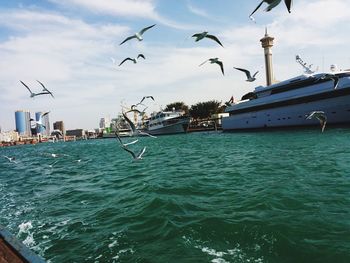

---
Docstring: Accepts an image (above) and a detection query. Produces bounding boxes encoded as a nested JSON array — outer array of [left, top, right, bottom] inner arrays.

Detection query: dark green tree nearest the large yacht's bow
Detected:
[[189, 100, 223, 119]]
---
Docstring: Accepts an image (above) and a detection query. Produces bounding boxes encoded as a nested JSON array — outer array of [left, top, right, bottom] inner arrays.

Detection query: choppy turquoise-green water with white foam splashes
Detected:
[[0, 129, 350, 263]]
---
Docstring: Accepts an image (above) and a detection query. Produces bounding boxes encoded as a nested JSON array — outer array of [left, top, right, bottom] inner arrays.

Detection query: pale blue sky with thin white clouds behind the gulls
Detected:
[[0, 0, 350, 131]]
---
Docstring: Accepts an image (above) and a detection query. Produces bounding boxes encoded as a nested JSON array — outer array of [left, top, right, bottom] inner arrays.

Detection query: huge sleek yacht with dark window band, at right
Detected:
[[222, 70, 350, 131]]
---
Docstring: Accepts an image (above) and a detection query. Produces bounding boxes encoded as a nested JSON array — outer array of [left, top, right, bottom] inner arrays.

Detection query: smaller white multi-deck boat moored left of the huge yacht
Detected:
[[143, 110, 190, 135]]
